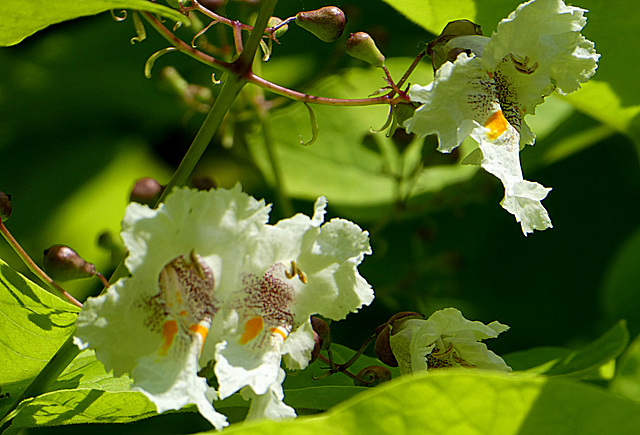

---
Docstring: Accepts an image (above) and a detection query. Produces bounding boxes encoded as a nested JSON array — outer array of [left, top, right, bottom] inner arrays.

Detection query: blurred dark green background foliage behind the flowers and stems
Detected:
[[0, 0, 640, 431]]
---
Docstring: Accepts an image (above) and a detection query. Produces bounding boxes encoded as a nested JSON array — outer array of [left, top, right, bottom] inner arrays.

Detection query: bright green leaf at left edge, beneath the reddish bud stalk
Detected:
[[0, 260, 79, 416]]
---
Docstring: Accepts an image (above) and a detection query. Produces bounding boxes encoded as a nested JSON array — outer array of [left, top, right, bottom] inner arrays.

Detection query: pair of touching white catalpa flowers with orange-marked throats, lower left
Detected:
[[76, 186, 373, 429]]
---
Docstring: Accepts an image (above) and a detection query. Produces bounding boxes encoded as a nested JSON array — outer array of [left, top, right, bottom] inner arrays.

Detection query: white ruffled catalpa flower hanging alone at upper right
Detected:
[[404, 0, 600, 236]]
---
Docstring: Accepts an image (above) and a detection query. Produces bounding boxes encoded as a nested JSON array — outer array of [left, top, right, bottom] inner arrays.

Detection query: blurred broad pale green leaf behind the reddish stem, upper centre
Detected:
[[248, 59, 476, 207]]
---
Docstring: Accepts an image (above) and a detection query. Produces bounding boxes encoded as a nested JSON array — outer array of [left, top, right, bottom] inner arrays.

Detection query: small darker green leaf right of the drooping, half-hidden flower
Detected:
[[504, 320, 629, 376]]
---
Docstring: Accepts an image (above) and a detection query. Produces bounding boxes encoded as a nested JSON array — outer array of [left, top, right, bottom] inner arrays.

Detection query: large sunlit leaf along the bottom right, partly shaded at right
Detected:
[[198, 369, 640, 435]]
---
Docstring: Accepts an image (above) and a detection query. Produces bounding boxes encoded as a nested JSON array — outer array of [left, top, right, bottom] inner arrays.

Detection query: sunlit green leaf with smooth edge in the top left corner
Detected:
[[0, 0, 190, 46]]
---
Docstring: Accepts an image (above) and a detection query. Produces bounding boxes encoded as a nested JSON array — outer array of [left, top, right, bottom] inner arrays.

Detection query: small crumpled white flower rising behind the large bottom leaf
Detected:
[[389, 308, 511, 374]]
